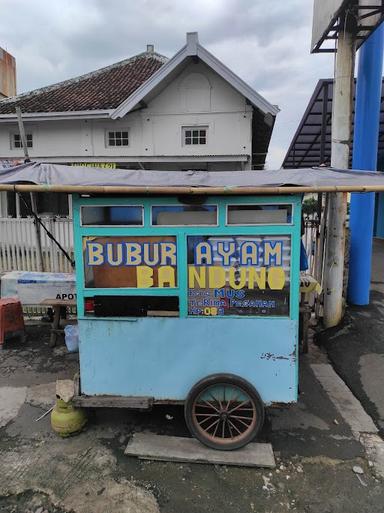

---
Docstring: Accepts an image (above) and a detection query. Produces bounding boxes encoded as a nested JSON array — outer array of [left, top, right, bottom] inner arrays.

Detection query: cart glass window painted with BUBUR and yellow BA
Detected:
[[83, 235, 177, 289]]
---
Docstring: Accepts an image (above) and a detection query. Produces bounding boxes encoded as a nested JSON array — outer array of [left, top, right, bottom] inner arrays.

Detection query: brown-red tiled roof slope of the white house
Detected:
[[0, 52, 167, 114]]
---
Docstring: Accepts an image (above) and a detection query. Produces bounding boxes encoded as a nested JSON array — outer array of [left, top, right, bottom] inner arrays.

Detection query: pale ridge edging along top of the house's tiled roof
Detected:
[[0, 51, 169, 105]]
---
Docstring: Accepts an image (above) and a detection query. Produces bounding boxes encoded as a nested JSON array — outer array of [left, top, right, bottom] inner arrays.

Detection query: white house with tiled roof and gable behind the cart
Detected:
[[0, 32, 279, 215]]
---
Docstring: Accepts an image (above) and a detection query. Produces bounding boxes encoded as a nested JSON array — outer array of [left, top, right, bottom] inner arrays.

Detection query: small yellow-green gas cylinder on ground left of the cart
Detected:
[[51, 399, 87, 437]]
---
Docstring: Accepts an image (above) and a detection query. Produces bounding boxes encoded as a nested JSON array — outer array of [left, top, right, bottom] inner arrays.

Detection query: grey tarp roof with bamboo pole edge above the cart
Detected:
[[0, 162, 384, 195]]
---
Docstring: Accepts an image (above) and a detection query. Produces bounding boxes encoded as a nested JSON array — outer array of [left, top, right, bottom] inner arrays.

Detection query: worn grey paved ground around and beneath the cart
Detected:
[[0, 320, 384, 513]]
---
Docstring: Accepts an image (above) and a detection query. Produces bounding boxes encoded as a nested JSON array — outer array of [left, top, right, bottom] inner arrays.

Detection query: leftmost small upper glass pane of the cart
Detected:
[[81, 205, 144, 226]]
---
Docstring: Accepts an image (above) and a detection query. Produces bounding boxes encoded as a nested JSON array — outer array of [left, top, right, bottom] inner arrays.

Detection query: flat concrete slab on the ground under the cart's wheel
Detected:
[[125, 433, 276, 468]]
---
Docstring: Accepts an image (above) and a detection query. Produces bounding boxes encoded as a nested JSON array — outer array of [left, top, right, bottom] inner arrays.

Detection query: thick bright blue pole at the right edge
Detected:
[[348, 25, 384, 305]]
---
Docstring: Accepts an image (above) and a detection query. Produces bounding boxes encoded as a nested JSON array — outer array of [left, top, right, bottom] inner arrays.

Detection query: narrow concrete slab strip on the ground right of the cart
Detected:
[[311, 363, 378, 436]]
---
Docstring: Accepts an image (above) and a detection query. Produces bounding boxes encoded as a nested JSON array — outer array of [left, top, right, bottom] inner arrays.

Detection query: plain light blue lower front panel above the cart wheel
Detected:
[[80, 319, 297, 404]]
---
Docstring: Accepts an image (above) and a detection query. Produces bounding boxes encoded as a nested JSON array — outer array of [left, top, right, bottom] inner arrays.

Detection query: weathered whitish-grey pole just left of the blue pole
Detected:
[[324, 24, 355, 328]]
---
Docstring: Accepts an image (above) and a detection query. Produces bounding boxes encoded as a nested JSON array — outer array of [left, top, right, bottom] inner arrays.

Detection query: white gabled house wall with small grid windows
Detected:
[[0, 62, 252, 169]]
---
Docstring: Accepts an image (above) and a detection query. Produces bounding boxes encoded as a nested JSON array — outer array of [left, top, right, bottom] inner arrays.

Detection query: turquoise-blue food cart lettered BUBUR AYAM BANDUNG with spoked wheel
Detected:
[[73, 194, 301, 449]]
